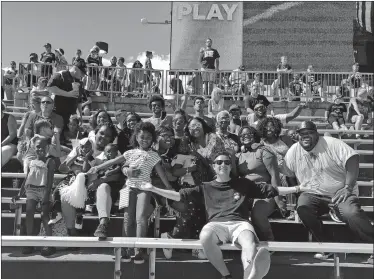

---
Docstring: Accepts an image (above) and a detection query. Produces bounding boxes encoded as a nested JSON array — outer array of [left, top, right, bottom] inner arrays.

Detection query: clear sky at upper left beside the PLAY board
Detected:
[[1, 2, 171, 68]]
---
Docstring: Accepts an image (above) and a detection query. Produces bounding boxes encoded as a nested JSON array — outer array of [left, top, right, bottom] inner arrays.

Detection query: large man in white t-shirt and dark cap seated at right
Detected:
[[281, 121, 374, 259]]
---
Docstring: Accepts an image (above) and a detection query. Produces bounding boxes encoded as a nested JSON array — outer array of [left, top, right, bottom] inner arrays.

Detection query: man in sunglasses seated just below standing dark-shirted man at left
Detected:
[[25, 97, 64, 142]]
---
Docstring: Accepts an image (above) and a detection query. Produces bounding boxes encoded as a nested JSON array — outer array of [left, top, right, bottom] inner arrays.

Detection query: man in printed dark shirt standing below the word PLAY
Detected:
[[199, 38, 220, 95]]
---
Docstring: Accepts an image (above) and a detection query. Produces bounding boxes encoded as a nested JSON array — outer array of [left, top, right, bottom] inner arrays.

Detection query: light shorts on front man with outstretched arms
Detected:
[[201, 221, 259, 245]]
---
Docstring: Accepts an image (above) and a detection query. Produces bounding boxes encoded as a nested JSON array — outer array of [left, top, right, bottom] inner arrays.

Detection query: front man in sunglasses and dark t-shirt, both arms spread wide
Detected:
[[140, 152, 307, 279]]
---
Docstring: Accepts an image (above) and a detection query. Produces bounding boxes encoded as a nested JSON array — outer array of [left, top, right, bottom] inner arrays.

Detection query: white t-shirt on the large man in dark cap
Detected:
[[283, 137, 358, 198]]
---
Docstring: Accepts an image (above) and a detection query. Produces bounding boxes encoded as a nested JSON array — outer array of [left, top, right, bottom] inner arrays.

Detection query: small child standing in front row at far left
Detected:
[[14, 134, 56, 256]]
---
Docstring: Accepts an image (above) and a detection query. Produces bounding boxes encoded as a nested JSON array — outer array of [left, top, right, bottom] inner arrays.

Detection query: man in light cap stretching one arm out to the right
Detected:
[[247, 103, 306, 128]]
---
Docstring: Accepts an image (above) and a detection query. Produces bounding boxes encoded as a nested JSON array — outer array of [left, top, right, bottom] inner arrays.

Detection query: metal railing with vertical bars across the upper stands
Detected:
[[13, 63, 374, 101]]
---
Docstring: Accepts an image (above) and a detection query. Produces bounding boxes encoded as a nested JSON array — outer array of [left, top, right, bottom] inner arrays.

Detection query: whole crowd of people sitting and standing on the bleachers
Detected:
[[1, 39, 373, 279]]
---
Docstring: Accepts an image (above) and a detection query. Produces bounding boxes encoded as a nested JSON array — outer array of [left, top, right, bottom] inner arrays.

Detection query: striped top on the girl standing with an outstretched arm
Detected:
[[123, 148, 161, 188]]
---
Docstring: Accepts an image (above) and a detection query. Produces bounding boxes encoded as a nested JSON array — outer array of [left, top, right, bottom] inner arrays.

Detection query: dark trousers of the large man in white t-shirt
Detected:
[[297, 192, 374, 243]]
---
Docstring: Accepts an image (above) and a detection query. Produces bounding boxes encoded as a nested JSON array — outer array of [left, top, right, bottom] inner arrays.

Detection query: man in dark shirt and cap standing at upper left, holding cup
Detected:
[[47, 61, 86, 127]]
